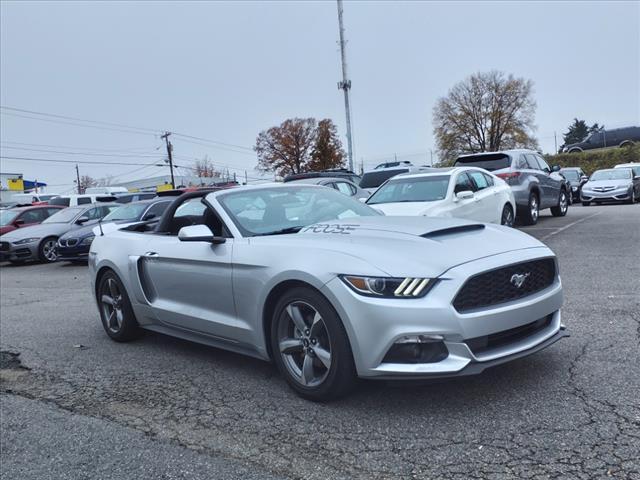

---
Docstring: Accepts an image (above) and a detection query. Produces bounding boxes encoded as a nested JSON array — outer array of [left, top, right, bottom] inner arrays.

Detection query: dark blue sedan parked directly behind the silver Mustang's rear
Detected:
[[56, 197, 173, 262]]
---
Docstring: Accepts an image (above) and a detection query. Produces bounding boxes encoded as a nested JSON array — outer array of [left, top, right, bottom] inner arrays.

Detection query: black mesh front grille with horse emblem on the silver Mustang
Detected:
[[453, 258, 556, 312]]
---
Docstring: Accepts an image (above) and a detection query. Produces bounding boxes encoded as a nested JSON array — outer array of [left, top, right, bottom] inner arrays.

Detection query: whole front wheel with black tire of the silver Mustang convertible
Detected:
[[271, 287, 356, 402]]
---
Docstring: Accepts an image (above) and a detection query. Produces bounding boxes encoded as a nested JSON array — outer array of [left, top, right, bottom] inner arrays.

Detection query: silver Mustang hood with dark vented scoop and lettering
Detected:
[[251, 216, 549, 277]]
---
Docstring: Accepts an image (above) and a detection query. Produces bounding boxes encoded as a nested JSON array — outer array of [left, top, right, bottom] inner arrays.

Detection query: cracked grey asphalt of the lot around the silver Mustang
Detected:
[[0, 204, 640, 480]]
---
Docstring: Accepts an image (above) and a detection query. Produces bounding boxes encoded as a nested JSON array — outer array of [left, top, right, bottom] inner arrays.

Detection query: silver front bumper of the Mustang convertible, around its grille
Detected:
[[324, 248, 567, 379]]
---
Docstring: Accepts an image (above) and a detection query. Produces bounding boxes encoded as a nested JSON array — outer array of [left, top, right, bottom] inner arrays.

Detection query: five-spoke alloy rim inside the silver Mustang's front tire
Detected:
[[278, 301, 331, 387]]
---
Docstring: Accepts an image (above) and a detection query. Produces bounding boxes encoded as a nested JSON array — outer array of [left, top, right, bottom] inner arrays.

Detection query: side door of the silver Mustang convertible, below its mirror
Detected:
[[140, 197, 239, 341]]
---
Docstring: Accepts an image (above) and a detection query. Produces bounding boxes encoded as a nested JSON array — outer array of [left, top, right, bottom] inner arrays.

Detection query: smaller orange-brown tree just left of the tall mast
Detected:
[[253, 118, 316, 176]]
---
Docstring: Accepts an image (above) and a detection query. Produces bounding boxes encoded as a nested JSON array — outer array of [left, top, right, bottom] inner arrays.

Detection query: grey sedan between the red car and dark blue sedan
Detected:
[[0, 203, 119, 263]]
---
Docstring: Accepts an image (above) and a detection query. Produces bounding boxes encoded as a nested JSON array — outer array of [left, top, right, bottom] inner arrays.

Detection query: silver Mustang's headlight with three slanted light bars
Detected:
[[340, 275, 434, 298]]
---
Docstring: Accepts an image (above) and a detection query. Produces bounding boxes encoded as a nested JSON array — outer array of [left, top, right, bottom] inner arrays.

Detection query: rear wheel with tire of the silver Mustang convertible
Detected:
[[96, 271, 141, 342]]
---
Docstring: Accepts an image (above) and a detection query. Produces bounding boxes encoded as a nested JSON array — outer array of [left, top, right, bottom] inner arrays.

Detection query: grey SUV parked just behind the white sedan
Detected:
[[455, 150, 571, 225]]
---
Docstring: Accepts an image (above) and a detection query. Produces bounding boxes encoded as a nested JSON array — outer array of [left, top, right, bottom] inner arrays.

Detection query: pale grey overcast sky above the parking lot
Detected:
[[0, 0, 640, 192]]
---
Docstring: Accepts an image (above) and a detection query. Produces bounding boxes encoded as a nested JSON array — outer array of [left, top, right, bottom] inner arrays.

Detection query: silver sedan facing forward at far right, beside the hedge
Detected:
[[580, 168, 640, 206]]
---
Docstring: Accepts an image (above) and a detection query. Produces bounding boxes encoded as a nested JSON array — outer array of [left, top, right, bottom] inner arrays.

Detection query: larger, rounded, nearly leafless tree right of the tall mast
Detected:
[[433, 71, 537, 160]]
